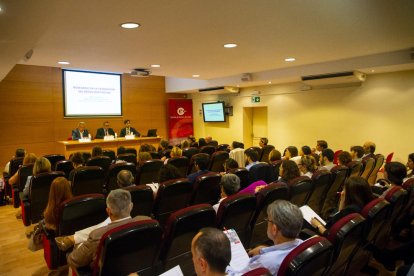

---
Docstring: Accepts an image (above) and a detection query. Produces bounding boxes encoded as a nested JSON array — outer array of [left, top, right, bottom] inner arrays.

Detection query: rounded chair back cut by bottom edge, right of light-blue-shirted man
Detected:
[[277, 236, 333, 276]]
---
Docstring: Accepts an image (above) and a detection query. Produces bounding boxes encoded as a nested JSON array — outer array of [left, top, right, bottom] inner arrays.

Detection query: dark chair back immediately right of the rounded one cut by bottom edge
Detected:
[[326, 213, 365, 275]]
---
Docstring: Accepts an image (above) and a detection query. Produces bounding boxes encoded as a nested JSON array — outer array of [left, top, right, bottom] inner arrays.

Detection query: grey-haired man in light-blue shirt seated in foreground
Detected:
[[228, 200, 303, 275]]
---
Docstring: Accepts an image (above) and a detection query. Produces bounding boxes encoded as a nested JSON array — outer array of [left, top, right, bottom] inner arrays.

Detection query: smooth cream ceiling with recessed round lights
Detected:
[[0, 0, 414, 90]]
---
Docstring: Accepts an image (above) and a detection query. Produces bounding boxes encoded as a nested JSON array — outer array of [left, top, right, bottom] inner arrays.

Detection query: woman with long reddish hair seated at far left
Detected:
[[43, 177, 73, 231]]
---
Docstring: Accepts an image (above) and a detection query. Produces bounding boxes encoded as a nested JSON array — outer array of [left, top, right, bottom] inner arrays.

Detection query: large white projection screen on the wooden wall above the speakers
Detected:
[[62, 69, 122, 117]]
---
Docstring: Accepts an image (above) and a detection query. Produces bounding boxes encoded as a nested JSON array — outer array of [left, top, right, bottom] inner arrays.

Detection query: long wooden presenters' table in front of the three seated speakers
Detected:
[[57, 137, 161, 159]]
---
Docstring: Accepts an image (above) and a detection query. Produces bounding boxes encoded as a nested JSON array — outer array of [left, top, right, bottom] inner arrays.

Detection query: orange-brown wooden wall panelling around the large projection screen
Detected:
[[0, 65, 183, 169]]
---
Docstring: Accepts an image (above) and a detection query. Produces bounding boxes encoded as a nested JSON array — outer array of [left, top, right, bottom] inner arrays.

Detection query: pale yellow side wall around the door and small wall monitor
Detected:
[[191, 71, 414, 164]]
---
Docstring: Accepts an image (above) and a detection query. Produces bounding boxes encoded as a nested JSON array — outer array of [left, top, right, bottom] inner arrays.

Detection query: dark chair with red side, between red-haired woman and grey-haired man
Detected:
[[43, 194, 108, 269]]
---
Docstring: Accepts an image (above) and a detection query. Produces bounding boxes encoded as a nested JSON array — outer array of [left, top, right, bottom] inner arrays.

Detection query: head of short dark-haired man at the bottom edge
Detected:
[[191, 227, 231, 276]]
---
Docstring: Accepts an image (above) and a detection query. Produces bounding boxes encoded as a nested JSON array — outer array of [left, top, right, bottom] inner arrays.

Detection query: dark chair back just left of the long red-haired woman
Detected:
[[29, 172, 65, 223]]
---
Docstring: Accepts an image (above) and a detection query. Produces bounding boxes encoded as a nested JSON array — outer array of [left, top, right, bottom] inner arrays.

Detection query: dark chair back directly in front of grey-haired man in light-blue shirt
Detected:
[[249, 182, 289, 248]]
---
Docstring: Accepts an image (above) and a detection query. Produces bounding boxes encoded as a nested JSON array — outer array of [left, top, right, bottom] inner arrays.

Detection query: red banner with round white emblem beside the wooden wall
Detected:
[[168, 99, 194, 141]]
